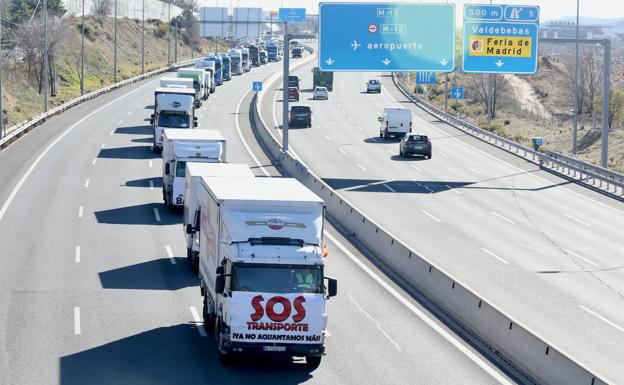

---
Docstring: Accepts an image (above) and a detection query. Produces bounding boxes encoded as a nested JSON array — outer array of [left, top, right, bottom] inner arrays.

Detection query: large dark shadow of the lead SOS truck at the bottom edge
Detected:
[[59, 324, 322, 385]]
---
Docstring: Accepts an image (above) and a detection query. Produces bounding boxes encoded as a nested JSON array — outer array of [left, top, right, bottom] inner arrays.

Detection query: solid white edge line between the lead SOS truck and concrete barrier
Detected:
[[323, 231, 511, 385]]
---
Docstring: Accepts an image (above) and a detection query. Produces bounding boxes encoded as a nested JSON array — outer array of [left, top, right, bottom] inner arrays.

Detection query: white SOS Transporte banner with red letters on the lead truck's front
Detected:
[[230, 291, 325, 344]]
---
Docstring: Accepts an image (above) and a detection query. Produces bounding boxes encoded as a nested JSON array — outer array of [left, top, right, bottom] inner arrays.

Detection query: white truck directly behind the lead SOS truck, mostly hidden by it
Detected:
[[182, 162, 254, 274]]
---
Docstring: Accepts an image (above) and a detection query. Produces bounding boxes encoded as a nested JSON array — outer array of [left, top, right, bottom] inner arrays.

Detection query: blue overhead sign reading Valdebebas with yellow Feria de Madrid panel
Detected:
[[462, 4, 540, 74]]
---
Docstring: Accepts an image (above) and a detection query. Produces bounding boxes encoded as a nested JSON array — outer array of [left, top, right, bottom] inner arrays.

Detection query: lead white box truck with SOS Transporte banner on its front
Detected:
[[198, 177, 337, 368]]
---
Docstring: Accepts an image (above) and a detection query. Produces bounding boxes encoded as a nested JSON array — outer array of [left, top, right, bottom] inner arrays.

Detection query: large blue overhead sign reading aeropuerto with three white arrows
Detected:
[[319, 3, 455, 72]]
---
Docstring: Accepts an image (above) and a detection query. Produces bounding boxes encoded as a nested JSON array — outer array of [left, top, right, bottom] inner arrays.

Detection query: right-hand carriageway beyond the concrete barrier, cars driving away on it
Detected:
[[261, 48, 624, 382]]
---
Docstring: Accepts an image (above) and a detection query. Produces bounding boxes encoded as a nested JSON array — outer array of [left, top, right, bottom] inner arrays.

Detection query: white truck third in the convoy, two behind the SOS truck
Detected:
[[162, 129, 225, 209]]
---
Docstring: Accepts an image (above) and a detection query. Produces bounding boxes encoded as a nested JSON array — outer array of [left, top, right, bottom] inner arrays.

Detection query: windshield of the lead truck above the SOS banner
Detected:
[[230, 264, 323, 294]]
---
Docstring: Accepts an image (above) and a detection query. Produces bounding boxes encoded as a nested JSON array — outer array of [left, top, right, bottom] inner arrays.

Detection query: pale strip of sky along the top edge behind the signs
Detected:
[[205, 0, 624, 20]]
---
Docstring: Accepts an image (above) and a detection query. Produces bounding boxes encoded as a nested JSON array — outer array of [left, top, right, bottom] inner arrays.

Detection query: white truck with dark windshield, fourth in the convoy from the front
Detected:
[[150, 87, 197, 154]]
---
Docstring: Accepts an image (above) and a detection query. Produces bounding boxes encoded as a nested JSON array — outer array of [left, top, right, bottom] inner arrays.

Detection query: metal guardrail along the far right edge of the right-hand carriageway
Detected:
[[392, 73, 624, 200]]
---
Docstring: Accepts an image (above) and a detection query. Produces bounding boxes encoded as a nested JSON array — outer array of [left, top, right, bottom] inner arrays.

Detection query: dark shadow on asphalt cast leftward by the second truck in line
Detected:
[[98, 256, 199, 290]]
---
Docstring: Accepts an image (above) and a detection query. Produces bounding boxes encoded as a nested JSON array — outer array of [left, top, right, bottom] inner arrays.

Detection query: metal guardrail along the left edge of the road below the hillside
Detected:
[[0, 59, 194, 150]]
